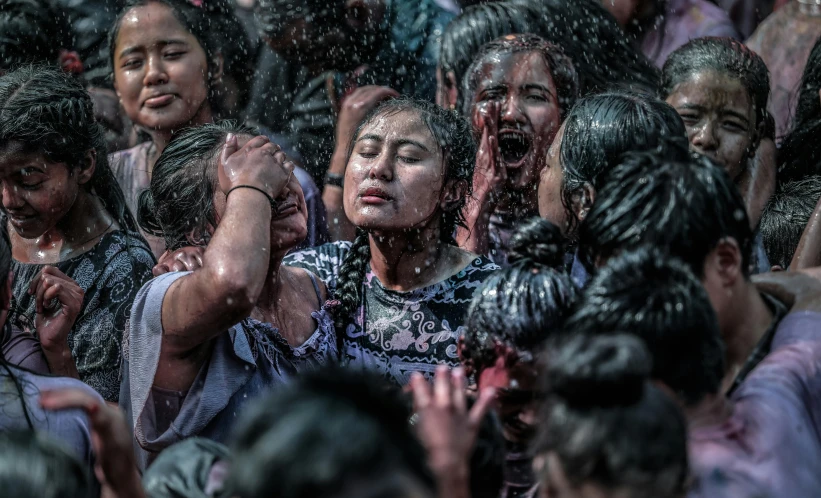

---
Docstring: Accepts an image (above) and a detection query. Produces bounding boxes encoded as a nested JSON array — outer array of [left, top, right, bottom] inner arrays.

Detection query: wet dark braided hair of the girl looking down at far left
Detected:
[[0, 66, 138, 232]]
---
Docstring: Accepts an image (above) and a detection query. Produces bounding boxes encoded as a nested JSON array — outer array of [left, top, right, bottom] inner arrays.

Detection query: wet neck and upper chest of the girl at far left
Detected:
[[10, 190, 114, 263]]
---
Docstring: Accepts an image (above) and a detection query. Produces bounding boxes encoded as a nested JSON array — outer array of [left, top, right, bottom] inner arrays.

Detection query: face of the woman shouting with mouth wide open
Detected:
[[473, 52, 561, 191]]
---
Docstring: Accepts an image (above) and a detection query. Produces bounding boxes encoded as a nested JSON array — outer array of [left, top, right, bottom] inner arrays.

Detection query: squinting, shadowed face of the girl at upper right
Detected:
[[667, 71, 757, 180]]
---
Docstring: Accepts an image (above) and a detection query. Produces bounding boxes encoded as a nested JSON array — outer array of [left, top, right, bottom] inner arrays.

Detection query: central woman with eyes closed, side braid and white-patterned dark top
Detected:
[[286, 99, 498, 385]]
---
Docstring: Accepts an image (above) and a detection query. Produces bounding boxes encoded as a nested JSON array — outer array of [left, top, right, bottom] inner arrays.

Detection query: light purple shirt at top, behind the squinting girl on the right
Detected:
[[641, 0, 739, 67]]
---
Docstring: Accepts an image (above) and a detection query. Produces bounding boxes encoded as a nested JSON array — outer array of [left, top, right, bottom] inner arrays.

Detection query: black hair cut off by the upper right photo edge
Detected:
[[777, 38, 821, 183]]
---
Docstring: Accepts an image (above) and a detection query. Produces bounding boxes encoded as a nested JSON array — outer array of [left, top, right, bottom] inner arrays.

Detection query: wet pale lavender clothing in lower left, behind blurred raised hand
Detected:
[[0, 367, 102, 482]]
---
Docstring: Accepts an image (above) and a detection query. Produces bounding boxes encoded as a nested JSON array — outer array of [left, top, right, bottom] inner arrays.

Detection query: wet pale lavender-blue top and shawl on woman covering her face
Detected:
[[120, 272, 339, 469]]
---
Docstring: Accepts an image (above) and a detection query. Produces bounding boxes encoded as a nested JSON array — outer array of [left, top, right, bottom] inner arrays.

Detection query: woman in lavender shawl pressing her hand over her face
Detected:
[[121, 122, 338, 468]]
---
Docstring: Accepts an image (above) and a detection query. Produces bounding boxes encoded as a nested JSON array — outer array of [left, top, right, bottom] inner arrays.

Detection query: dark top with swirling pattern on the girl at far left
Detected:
[[9, 230, 154, 402]]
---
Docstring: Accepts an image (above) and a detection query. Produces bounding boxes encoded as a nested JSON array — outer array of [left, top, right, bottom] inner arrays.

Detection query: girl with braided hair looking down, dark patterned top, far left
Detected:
[[0, 68, 154, 401]]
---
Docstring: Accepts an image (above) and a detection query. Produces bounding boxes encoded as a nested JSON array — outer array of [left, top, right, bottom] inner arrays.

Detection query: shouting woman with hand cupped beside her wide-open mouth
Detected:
[[457, 35, 579, 264]]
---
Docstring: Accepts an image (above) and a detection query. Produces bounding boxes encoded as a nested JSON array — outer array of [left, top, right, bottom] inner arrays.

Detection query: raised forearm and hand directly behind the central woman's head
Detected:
[[322, 86, 399, 241]]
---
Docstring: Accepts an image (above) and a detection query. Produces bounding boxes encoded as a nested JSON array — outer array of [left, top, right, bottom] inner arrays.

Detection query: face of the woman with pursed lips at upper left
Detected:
[[113, 2, 211, 132]]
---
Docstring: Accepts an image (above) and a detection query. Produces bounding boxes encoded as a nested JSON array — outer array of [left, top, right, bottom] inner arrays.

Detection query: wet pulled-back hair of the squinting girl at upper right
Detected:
[[661, 36, 772, 139]]
